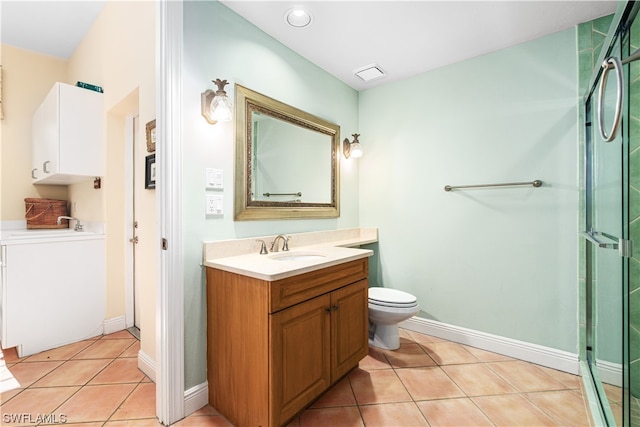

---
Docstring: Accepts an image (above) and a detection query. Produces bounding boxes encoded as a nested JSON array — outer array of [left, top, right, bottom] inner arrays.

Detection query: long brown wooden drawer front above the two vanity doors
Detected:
[[270, 258, 369, 313]]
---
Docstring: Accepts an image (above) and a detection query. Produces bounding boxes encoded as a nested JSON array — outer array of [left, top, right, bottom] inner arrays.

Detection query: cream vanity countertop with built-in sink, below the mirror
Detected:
[[204, 246, 373, 281]]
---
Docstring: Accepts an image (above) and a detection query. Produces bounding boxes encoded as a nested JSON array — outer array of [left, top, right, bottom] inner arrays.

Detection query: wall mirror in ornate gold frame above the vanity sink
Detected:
[[234, 84, 340, 221]]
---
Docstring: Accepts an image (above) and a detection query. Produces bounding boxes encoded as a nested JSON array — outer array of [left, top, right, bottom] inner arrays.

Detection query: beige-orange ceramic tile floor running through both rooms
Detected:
[[0, 330, 589, 427]]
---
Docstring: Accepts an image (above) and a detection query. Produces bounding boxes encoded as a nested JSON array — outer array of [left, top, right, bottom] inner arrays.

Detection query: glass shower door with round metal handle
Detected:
[[583, 30, 629, 426]]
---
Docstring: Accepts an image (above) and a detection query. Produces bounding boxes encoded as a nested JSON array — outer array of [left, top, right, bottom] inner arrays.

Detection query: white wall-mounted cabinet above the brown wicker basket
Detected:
[[31, 83, 105, 185]]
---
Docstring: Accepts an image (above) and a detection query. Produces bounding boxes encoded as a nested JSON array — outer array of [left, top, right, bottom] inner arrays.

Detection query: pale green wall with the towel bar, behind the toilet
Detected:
[[359, 29, 579, 354]]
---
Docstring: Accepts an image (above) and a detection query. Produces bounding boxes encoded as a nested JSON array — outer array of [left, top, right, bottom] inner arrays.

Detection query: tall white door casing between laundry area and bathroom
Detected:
[[156, 0, 185, 425]]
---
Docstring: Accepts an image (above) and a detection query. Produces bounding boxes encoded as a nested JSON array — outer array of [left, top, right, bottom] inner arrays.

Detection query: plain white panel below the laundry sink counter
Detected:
[[2, 238, 106, 357]]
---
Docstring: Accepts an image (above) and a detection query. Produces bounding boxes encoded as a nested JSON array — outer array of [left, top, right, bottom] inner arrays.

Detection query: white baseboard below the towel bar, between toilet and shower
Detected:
[[399, 317, 580, 375]]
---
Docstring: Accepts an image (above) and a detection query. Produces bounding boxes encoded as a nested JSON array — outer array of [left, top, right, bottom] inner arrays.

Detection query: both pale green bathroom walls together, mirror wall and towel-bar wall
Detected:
[[183, 1, 616, 394]]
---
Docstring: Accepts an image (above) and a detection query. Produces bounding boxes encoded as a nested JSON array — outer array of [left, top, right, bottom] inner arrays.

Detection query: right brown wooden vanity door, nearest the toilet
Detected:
[[331, 279, 369, 382]]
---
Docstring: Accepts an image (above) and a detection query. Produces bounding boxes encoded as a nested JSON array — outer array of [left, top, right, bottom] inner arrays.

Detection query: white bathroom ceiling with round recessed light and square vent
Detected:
[[222, 0, 617, 90]]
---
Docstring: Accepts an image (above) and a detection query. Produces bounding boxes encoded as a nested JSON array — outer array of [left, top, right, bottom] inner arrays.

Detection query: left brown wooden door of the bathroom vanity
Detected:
[[270, 294, 331, 425]]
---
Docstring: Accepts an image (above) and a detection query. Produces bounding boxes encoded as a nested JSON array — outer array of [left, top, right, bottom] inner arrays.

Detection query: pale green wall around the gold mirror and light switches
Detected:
[[183, 1, 359, 389]]
